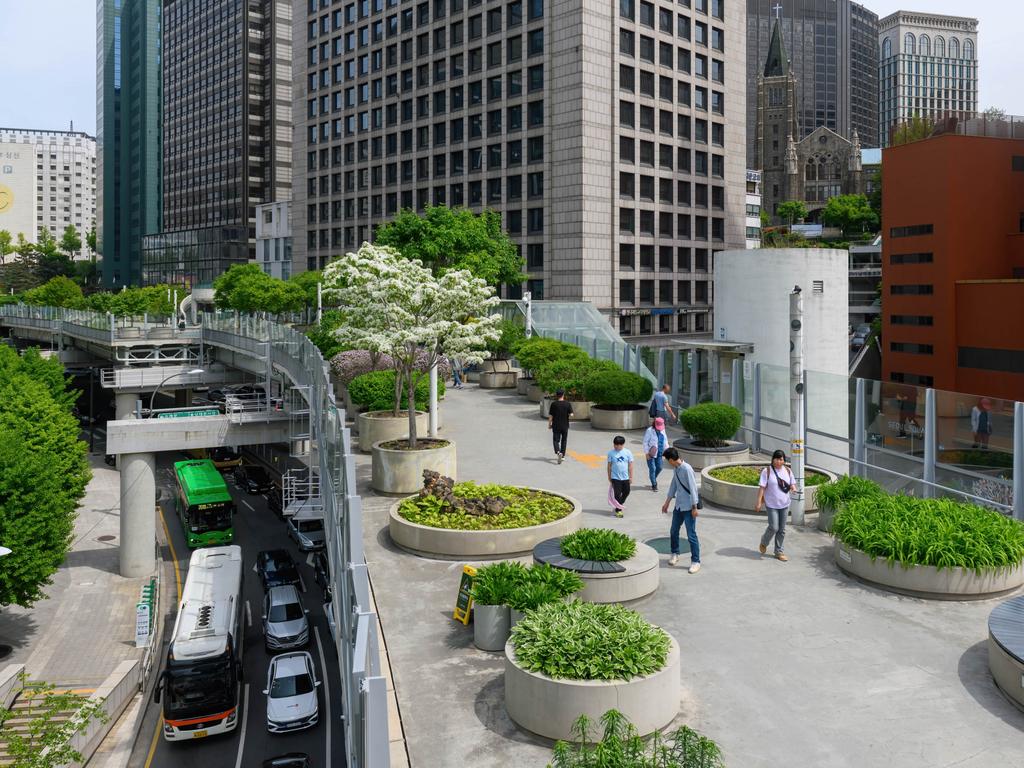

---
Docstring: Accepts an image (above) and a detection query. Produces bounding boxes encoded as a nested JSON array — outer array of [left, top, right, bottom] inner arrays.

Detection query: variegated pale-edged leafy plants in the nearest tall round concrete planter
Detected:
[[512, 600, 671, 680]]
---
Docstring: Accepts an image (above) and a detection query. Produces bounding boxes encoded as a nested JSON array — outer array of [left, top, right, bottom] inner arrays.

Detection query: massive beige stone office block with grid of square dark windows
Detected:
[[293, 0, 745, 336]]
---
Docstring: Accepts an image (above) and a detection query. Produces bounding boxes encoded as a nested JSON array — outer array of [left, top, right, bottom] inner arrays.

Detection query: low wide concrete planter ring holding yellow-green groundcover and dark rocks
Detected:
[[388, 493, 583, 559]]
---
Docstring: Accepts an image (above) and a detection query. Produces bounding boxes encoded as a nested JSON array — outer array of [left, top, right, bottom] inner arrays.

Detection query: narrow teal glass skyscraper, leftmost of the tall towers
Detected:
[[96, 0, 162, 288]]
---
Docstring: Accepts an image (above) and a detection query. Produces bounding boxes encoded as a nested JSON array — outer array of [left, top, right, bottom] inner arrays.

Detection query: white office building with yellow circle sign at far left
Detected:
[[0, 128, 96, 259]]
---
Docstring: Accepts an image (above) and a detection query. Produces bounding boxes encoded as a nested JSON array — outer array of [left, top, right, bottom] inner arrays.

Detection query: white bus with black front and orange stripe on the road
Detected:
[[154, 546, 245, 741]]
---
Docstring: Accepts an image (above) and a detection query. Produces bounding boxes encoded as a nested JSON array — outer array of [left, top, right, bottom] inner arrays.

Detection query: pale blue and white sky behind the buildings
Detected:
[[0, 0, 1024, 134]]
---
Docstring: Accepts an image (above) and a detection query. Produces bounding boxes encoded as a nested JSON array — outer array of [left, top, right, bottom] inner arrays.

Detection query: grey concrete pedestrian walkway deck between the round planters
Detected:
[[356, 385, 1024, 768]]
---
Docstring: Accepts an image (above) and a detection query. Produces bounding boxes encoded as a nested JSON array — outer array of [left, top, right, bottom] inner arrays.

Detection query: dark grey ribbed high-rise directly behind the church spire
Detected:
[[746, 0, 879, 168]]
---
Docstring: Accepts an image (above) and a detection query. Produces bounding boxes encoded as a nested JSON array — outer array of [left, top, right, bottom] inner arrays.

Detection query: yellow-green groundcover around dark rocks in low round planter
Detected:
[[398, 482, 572, 530]]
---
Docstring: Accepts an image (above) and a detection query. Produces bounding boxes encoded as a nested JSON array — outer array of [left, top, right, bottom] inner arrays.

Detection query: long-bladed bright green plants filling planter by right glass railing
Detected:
[[833, 496, 1024, 573]]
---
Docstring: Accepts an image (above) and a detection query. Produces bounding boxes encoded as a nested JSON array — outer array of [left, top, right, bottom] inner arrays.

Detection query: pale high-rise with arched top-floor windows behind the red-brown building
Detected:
[[879, 10, 978, 146]]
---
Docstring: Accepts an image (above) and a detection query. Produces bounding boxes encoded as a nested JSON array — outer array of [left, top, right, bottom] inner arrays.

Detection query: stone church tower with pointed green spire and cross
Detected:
[[757, 17, 800, 218]]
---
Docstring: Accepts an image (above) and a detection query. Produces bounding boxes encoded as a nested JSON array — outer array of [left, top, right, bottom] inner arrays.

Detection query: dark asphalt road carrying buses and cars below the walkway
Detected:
[[129, 454, 345, 768]]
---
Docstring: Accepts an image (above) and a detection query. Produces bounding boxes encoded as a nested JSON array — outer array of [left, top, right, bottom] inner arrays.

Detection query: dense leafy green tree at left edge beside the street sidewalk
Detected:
[[0, 347, 91, 607]]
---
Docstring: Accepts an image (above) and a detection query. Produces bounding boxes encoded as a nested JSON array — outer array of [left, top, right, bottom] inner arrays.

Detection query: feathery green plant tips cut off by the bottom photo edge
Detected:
[[548, 710, 725, 768]]
